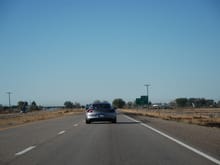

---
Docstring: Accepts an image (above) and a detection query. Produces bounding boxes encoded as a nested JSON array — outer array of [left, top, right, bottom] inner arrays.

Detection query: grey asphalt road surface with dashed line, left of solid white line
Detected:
[[0, 114, 216, 165]]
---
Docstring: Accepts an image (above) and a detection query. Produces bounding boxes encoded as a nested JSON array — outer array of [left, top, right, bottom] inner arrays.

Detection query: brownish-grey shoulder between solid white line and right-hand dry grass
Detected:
[[127, 114, 220, 160]]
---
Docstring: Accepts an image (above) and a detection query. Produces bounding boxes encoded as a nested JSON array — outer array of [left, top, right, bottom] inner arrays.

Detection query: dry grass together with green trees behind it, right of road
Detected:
[[113, 98, 220, 128]]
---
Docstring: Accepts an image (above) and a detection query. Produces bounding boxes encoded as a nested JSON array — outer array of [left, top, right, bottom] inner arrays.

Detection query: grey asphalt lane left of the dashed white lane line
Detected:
[[0, 115, 83, 164]]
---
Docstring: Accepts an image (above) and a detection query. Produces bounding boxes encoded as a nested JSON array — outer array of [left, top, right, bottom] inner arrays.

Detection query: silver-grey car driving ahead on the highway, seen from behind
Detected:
[[86, 102, 117, 124]]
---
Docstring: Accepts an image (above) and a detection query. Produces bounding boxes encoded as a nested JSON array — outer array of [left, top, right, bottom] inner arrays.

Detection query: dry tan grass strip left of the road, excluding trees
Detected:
[[0, 109, 83, 129]]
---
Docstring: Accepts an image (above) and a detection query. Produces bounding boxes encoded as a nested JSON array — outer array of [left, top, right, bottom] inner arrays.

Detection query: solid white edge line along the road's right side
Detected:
[[124, 115, 220, 165]]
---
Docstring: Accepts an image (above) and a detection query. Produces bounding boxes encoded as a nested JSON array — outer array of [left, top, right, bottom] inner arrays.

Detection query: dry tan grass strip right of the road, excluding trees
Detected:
[[122, 108, 220, 127]]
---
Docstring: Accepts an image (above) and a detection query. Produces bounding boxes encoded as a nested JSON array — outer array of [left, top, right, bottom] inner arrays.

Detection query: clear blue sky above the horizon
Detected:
[[0, 0, 220, 105]]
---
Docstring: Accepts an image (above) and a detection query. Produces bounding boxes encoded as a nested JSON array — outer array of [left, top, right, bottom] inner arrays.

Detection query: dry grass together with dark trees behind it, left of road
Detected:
[[0, 101, 84, 130]]
